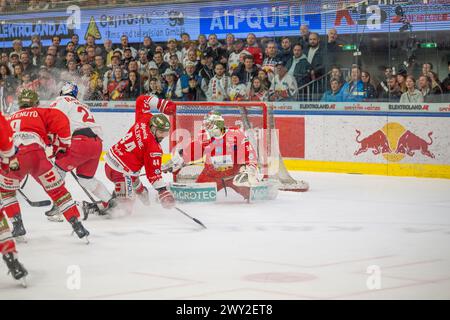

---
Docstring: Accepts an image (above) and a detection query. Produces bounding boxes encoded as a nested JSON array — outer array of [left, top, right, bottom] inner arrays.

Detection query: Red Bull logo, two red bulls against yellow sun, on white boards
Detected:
[[354, 122, 434, 162]]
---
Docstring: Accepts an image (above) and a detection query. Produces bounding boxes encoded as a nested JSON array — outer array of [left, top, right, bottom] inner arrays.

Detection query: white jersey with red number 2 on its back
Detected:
[[50, 96, 103, 139]]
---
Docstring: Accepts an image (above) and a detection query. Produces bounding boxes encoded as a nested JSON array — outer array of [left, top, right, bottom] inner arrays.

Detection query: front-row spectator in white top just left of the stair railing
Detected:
[[269, 61, 298, 101]]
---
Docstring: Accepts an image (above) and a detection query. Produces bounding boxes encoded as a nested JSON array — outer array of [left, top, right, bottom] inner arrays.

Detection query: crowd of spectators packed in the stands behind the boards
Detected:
[[0, 26, 450, 102]]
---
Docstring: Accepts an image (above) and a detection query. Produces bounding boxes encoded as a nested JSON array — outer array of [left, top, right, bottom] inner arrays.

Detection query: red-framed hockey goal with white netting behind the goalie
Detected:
[[170, 101, 309, 191]]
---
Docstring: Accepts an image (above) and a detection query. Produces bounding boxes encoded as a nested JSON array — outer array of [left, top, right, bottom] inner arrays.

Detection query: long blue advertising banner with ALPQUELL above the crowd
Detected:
[[0, 0, 450, 48]]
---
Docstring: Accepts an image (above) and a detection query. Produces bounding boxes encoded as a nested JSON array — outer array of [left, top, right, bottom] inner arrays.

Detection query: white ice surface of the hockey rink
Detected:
[[0, 170, 450, 300]]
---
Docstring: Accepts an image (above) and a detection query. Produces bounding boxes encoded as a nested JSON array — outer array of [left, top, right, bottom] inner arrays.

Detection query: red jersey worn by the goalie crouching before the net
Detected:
[[183, 127, 257, 177]]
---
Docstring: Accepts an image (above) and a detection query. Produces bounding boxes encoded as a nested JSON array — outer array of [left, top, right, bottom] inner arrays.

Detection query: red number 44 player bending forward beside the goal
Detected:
[[105, 114, 175, 209]]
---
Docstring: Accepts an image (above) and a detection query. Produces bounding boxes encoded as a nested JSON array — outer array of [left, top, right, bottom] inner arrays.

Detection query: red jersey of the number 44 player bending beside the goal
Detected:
[[105, 121, 166, 189]]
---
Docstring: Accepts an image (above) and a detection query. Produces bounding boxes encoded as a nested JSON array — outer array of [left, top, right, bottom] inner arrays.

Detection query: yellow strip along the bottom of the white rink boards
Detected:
[[100, 152, 450, 179]]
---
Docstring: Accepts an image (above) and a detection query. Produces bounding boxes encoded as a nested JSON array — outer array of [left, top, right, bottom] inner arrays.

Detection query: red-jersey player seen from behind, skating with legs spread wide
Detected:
[[0, 89, 89, 238]]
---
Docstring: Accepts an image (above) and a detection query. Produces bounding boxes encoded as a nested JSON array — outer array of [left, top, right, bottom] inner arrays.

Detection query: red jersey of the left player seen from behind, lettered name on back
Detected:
[[6, 107, 71, 148]]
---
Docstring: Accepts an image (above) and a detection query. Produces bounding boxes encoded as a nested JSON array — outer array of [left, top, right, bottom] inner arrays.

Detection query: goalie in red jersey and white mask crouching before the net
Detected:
[[162, 111, 260, 199]]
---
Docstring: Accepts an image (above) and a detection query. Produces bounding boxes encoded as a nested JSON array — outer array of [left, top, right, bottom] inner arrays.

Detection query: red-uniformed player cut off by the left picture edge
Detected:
[[0, 113, 28, 281]]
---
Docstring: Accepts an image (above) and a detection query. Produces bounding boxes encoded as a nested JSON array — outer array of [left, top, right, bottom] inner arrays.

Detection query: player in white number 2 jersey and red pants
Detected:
[[46, 82, 113, 221]]
